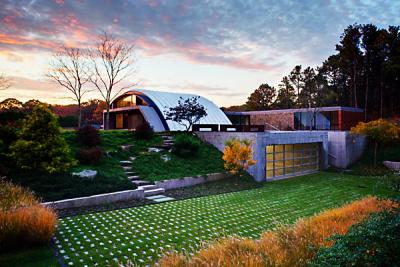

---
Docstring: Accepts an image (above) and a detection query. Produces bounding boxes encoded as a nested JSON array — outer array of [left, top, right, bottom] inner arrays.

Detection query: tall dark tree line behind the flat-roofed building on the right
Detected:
[[227, 24, 400, 121]]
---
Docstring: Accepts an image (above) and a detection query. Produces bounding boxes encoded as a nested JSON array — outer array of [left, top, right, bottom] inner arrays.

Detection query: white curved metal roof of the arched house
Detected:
[[130, 89, 232, 131]]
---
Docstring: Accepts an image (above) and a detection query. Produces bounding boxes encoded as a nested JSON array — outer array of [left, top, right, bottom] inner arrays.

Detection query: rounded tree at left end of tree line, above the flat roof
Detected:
[[246, 83, 276, 110]]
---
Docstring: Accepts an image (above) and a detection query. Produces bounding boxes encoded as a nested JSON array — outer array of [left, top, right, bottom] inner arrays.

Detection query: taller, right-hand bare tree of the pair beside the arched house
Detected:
[[90, 33, 134, 129]]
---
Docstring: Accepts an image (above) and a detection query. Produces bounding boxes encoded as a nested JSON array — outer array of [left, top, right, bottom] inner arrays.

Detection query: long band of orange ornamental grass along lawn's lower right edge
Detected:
[[158, 197, 398, 267]]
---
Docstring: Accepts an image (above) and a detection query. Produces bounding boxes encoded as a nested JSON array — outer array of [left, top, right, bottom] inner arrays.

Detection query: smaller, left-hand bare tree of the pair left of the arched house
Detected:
[[47, 47, 91, 128]]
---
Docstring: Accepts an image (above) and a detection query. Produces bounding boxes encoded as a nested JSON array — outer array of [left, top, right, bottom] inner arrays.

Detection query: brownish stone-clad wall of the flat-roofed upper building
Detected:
[[250, 112, 294, 131]]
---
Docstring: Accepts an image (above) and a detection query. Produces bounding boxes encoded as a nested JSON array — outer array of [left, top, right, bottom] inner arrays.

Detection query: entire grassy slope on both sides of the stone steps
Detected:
[[11, 131, 224, 201]]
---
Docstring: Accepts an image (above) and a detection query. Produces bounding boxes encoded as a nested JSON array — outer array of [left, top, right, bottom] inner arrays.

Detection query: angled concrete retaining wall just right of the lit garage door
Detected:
[[328, 131, 367, 169]]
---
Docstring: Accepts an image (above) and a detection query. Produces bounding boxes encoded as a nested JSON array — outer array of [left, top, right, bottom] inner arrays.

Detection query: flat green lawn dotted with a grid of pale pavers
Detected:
[[55, 172, 394, 266]]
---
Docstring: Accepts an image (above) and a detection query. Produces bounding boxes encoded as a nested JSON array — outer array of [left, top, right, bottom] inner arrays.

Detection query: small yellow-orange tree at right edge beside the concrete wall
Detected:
[[351, 119, 400, 166]]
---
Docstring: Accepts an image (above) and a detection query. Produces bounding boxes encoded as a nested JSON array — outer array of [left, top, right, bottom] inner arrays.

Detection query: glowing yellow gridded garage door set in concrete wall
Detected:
[[266, 143, 319, 179]]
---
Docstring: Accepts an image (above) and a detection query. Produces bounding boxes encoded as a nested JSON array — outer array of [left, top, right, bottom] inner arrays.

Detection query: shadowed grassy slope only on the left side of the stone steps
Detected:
[[11, 131, 139, 201]]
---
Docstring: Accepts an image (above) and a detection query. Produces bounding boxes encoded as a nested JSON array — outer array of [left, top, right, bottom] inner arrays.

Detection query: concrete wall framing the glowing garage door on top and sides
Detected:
[[196, 131, 328, 182]]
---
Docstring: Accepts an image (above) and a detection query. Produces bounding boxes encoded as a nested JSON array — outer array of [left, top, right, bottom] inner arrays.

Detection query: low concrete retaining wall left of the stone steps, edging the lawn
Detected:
[[42, 189, 144, 209]]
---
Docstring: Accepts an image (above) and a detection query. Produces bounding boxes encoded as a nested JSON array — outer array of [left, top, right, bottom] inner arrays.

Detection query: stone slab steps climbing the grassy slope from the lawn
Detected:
[[119, 146, 174, 202]]
